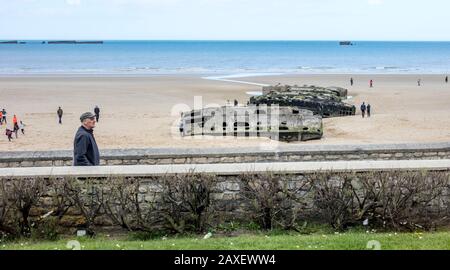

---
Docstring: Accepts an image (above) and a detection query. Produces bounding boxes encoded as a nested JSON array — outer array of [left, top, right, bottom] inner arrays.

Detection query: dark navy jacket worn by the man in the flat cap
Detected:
[[73, 126, 100, 166]]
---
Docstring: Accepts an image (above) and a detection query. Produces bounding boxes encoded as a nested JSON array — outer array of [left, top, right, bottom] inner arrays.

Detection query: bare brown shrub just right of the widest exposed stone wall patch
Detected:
[[240, 172, 308, 230]]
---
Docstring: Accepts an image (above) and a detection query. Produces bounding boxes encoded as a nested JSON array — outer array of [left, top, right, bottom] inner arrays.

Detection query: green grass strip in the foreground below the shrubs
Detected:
[[0, 232, 450, 250]]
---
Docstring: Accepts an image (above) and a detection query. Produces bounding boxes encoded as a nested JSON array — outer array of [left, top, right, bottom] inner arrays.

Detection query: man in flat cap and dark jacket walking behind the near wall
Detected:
[[73, 112, 100, 166]]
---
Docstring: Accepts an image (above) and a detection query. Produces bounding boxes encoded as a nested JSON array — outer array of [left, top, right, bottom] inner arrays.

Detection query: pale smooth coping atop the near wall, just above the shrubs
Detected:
[[0, 159, 450, 178]]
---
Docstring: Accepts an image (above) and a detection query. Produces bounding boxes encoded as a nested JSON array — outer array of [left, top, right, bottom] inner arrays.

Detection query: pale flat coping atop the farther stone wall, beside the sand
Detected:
[[0, 142, 450, 162]]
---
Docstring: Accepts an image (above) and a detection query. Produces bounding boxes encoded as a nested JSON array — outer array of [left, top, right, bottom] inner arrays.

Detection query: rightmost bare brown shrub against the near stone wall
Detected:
[[365, 172, 449, 231]]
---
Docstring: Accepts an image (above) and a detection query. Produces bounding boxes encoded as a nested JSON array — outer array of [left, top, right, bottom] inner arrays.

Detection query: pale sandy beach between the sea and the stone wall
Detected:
[[0, 75, 450, 151]]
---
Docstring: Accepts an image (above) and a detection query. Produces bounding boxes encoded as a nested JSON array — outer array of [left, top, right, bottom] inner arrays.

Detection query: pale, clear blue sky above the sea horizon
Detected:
[[0, 0, 450, 41]]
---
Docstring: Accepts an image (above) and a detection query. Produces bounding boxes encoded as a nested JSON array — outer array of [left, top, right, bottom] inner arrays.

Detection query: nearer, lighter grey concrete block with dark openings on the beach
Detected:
[[180, 106, 323, 142]]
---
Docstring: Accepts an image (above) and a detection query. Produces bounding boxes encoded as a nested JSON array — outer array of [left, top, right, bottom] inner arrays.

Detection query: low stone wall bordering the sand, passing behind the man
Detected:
[[0, 143, 450, 168]]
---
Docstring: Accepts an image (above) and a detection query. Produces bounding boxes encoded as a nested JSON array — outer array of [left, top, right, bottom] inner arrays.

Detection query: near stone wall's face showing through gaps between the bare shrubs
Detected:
[[0, 165, 450, 230]]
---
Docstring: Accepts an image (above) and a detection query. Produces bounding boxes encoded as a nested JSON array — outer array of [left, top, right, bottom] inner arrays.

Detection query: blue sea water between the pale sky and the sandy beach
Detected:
[[0, 41, 450, 75]]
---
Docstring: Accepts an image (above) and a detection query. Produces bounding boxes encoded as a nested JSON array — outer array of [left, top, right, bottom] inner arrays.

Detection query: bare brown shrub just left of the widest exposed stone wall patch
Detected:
[[159, 172, 214, 233]]
